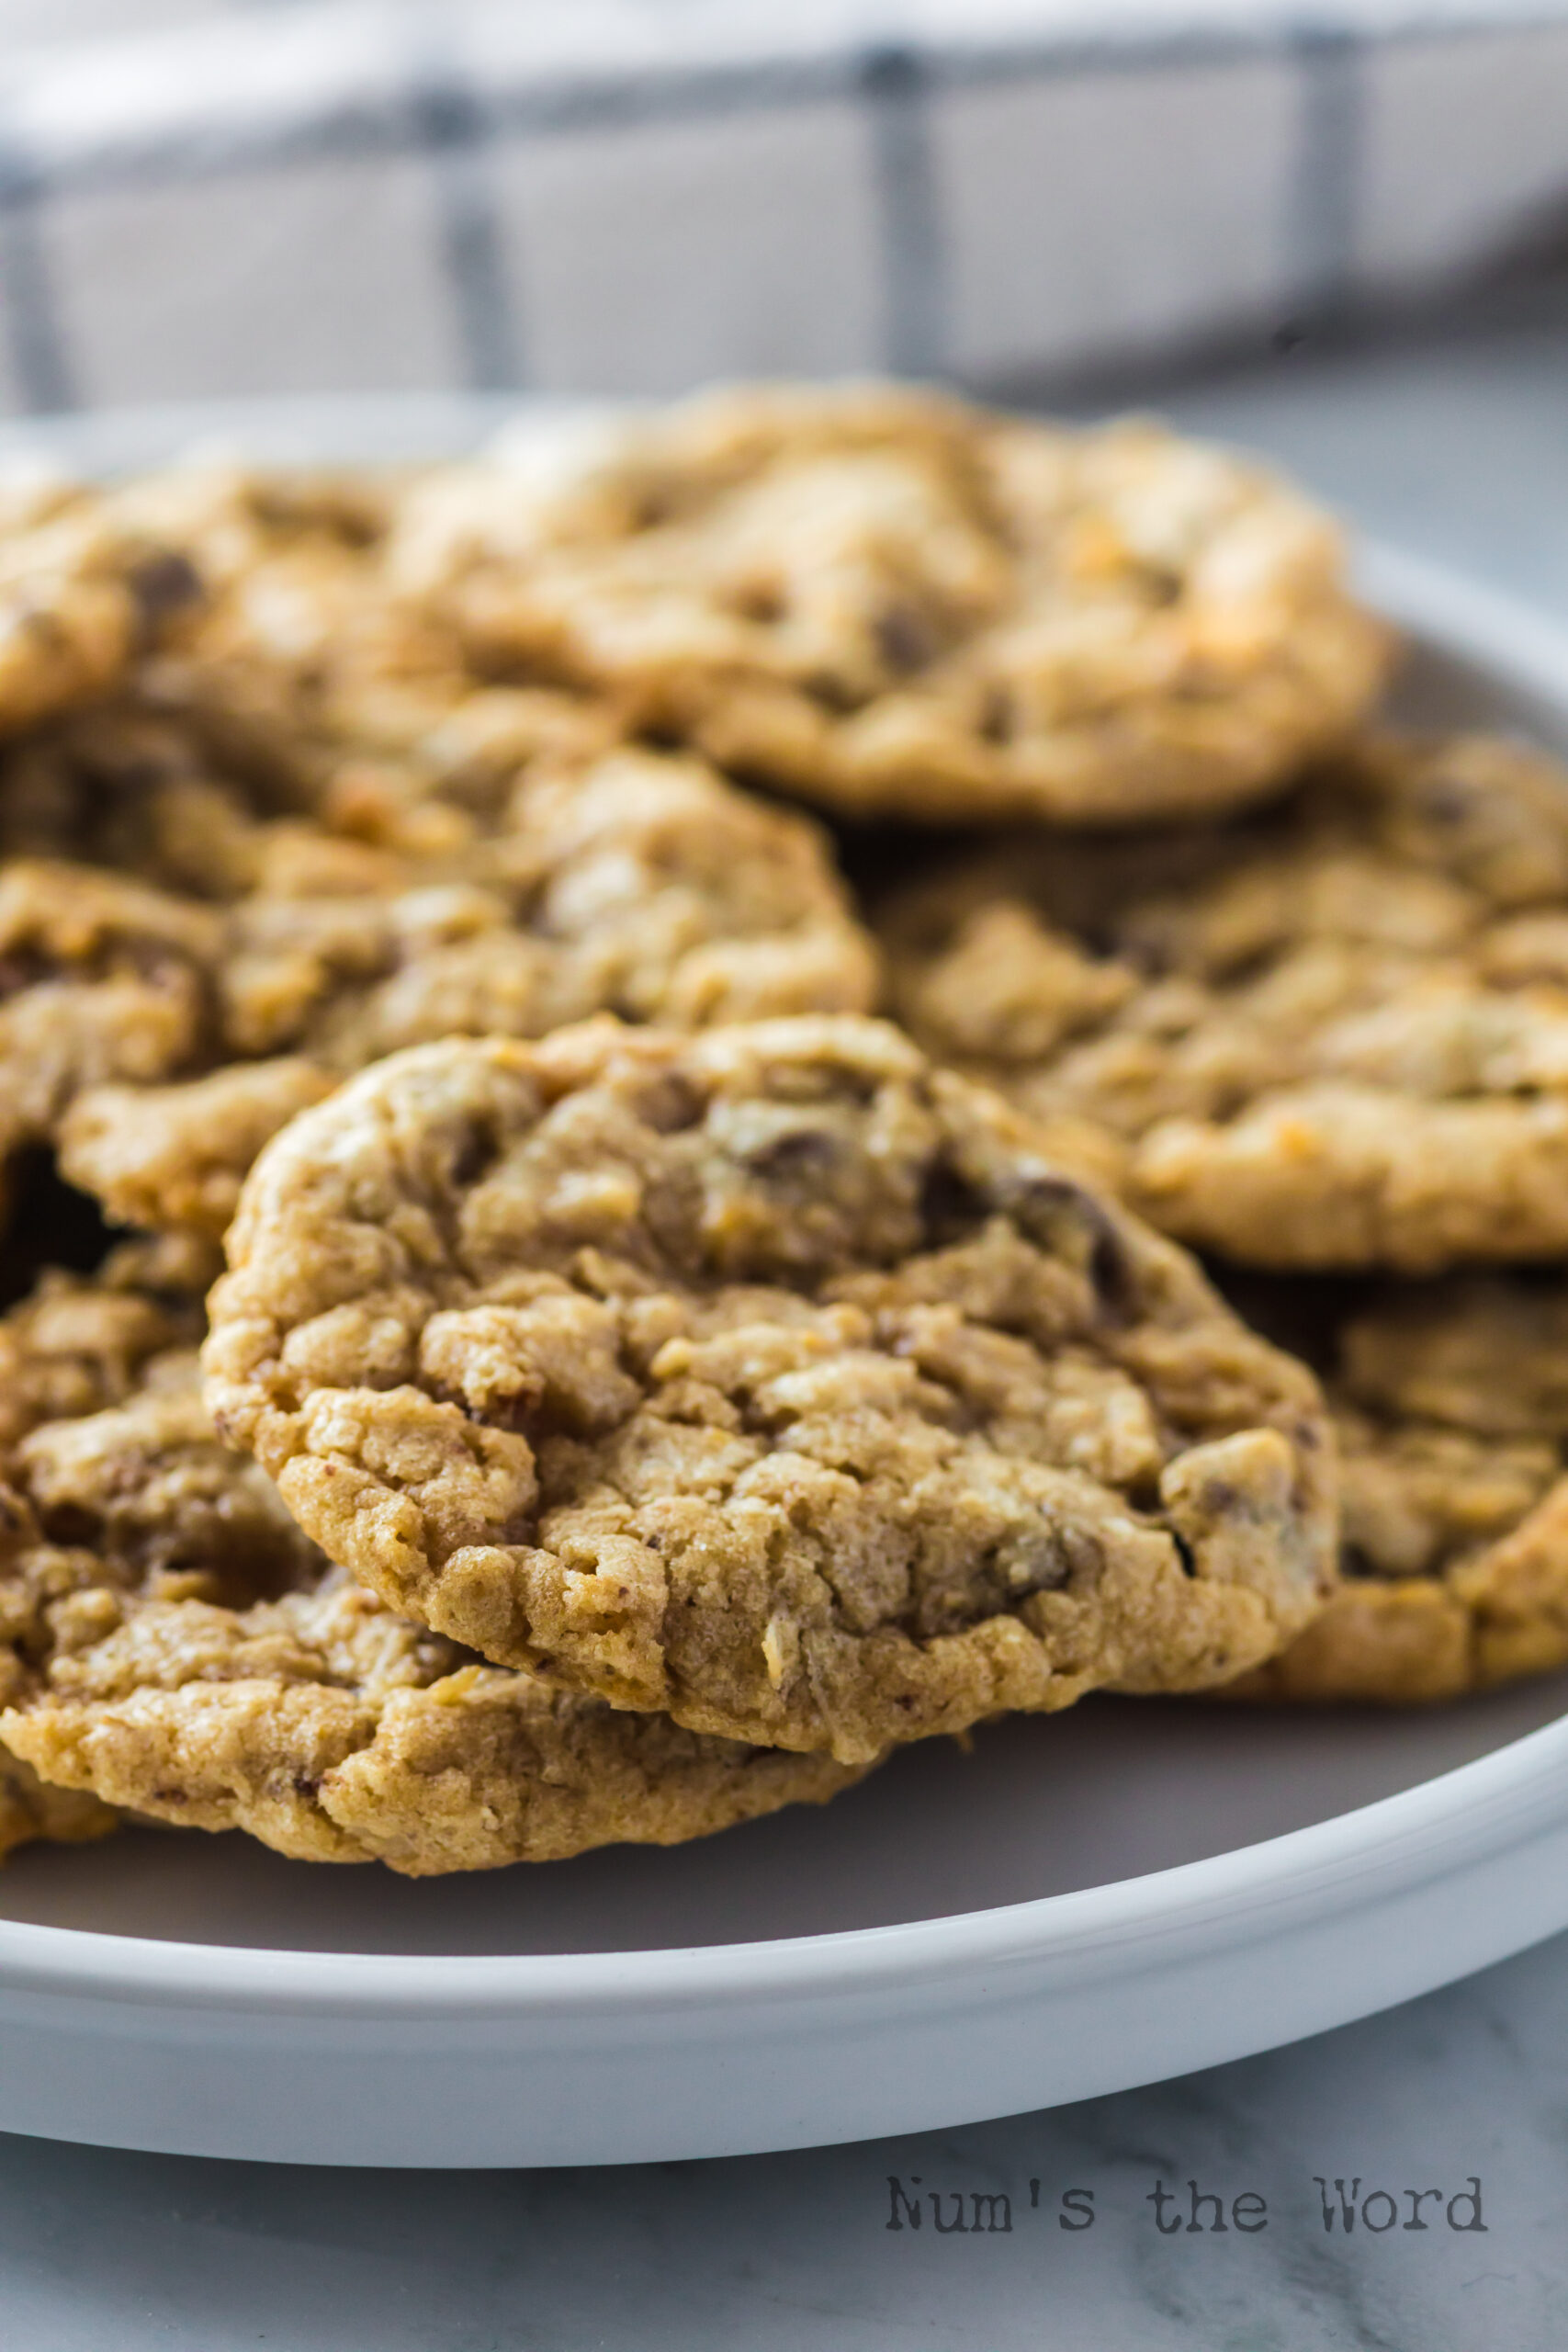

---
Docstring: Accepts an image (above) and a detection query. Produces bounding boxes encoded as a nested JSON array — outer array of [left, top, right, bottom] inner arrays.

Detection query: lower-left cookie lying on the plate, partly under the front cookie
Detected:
[[0, 1317, 861, 1877]]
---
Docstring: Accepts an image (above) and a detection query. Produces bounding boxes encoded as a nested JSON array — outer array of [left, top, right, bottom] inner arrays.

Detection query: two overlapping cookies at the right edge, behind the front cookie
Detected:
[[884, 736, 1568, 1701]]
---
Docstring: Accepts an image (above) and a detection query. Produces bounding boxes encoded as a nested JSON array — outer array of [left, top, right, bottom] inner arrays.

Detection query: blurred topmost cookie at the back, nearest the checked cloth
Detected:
[[386, 383, 1387, 826]]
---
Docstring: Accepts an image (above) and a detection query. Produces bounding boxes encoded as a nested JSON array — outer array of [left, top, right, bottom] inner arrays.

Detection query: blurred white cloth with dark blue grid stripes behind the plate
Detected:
[[0, 0, 1568, 414]]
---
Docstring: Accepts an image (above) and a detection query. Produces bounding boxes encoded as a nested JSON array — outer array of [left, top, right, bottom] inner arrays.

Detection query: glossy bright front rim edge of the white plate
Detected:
[[0, 1713, 1568, 2023]]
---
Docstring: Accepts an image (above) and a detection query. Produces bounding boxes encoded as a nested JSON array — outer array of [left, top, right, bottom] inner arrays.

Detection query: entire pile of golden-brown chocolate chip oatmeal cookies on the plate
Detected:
[[0, 388, 1568, 1872]]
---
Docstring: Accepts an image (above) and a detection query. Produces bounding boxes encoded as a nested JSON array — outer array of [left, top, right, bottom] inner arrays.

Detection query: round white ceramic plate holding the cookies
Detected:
[[0, 402, 1568, 2164]]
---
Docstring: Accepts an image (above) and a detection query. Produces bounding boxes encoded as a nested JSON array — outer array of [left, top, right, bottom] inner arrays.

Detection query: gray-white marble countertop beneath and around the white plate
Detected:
[[0, 332, 1568, 2352]]
